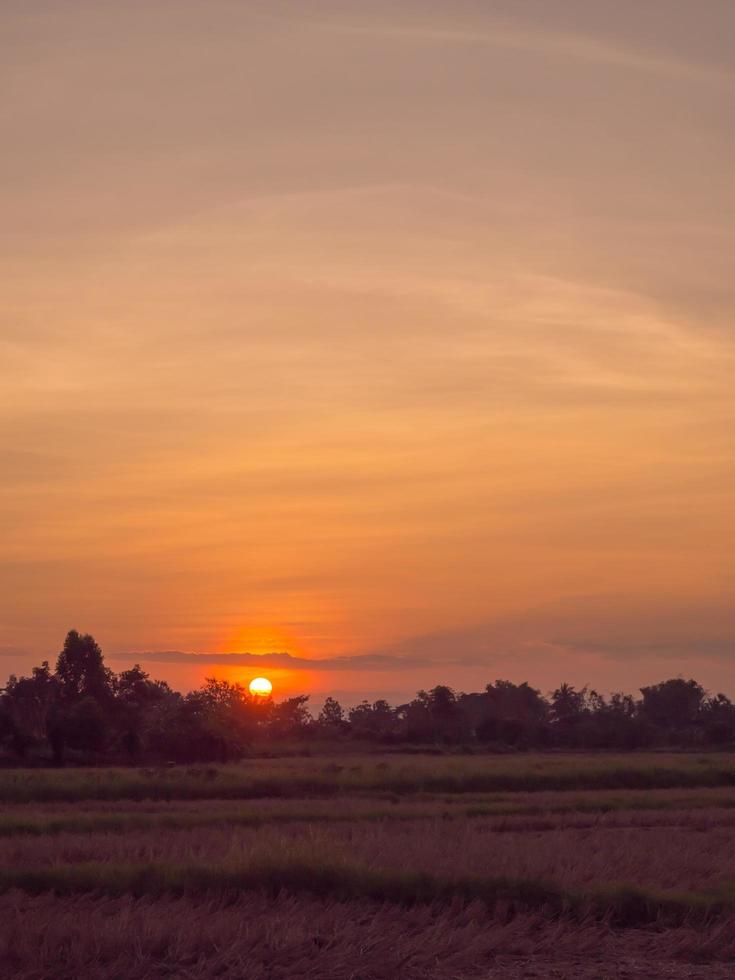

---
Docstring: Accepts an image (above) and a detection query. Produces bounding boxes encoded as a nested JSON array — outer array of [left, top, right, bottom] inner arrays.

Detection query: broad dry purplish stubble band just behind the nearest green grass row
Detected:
[[0, 811, 735, 891]]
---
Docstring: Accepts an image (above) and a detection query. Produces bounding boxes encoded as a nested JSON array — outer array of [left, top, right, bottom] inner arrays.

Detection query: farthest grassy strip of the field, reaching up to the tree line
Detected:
[[0, 753, 735, 803]]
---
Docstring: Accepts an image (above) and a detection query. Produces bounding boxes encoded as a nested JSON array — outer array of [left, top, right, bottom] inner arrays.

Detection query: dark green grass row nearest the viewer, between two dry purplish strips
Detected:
[[0, 861, 735, 927]]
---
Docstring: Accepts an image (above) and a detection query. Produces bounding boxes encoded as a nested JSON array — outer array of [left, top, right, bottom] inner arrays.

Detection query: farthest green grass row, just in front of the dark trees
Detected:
[[0, 760, 735, 803]]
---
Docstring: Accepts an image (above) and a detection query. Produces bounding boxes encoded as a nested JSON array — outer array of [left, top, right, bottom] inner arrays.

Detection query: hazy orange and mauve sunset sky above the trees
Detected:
[[0, 0, 735, 702]]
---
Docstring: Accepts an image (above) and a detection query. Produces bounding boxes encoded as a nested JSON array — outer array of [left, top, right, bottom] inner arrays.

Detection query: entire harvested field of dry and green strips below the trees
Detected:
[[0, 754, 735, 980]]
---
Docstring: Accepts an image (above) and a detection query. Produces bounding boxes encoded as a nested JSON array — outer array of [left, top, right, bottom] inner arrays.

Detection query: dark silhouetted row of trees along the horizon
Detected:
[[0, 630, 735, 765]]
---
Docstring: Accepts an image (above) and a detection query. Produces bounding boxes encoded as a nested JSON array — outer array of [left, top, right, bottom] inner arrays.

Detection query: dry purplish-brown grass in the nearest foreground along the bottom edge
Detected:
[[0, 892, 735, 980]]
